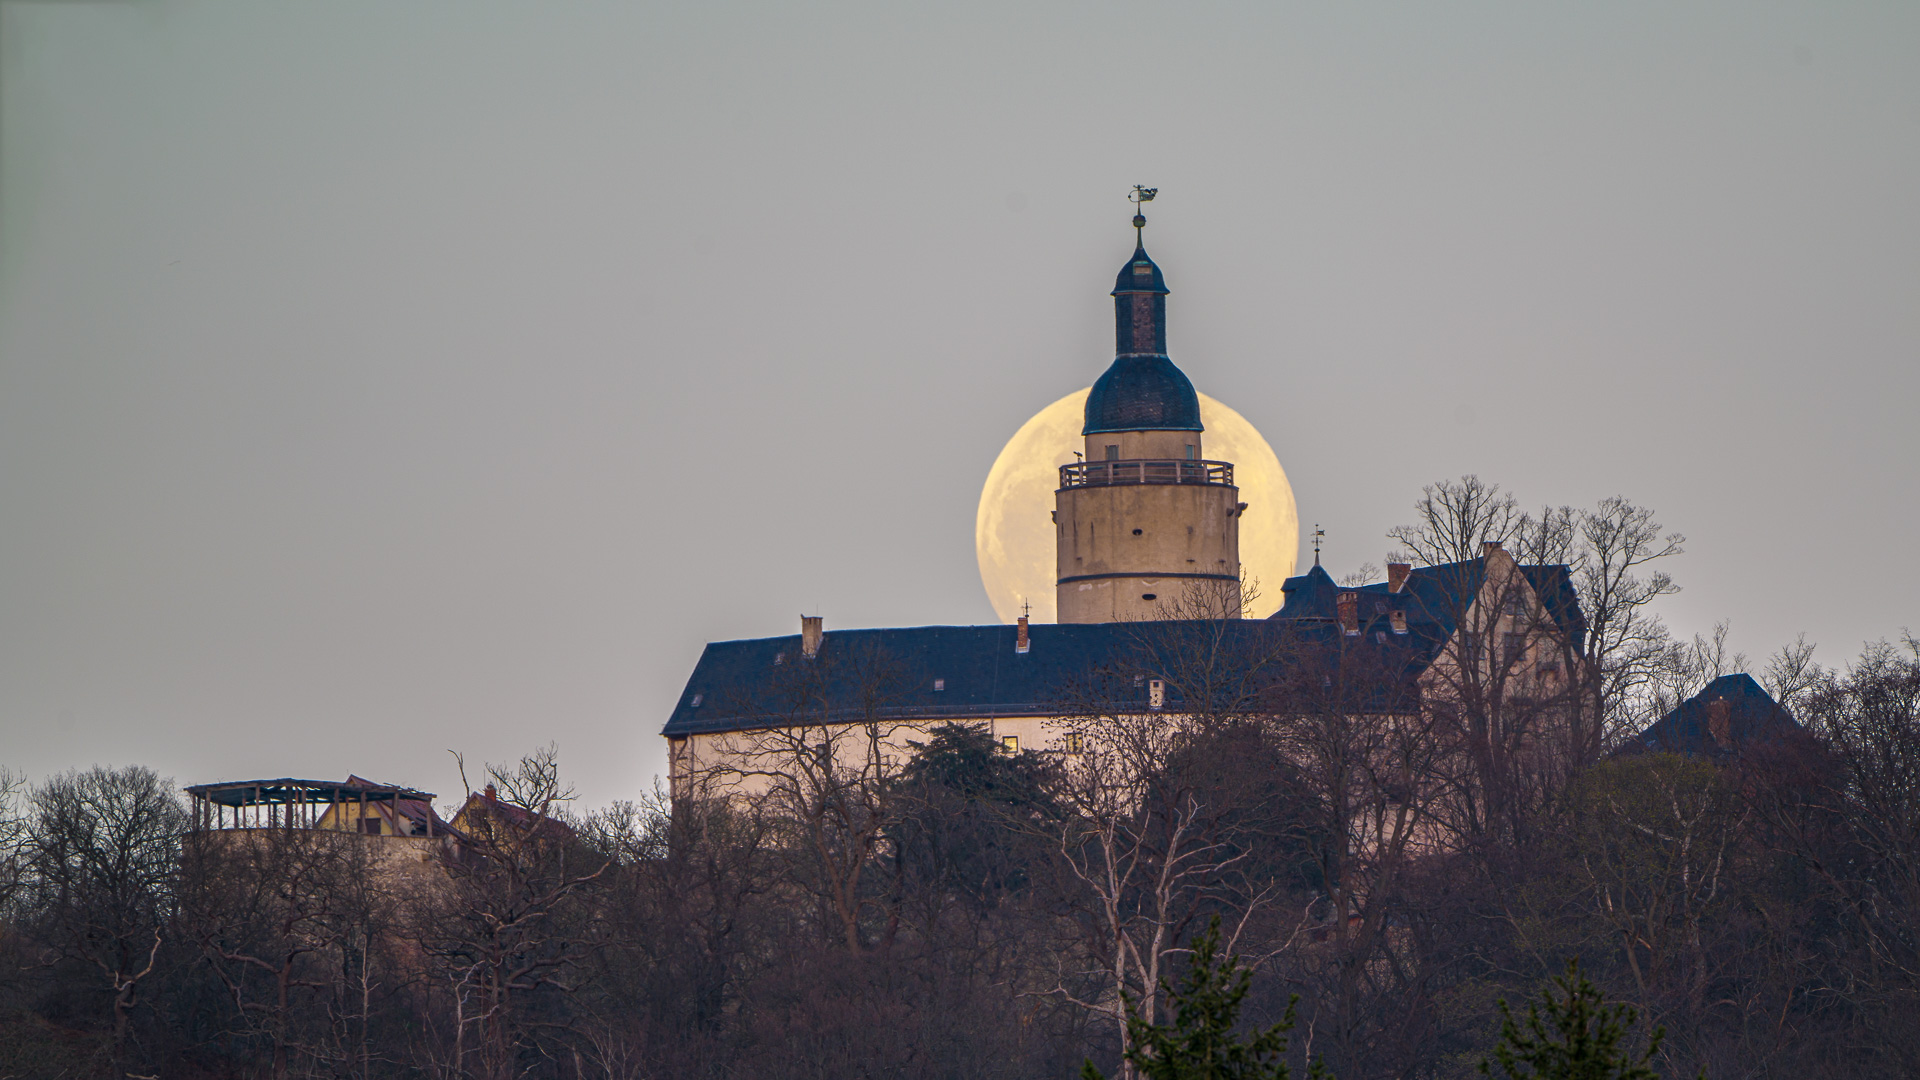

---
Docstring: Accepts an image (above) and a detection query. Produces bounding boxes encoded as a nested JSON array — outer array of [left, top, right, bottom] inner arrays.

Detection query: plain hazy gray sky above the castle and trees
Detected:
[[0, 0, 1920, 803]]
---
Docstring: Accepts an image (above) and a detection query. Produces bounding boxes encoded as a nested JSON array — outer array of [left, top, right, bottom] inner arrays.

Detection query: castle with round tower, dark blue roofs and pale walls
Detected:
[[660, 215, 1586, 796]]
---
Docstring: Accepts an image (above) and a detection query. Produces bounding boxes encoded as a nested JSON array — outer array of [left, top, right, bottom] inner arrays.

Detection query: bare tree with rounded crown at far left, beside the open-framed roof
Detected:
[[27, 767, 186, 1053]]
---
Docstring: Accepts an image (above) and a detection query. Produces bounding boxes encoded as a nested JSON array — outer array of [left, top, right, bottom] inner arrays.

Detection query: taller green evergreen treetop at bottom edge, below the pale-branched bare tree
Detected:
[[1081, 915, 1332, 1080]]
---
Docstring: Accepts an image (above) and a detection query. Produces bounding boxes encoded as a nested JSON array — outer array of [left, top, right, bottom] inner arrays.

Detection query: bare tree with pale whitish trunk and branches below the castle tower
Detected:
[[1033, 611, 1288, 1076]]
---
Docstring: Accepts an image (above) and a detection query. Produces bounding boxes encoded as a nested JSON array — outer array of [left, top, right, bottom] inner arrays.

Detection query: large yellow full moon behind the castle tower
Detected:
[[973, 390, 1300, 623]]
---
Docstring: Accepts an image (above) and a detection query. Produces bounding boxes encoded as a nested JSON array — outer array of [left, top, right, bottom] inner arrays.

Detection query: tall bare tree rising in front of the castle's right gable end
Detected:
[[1388, 475, 1684, 822]]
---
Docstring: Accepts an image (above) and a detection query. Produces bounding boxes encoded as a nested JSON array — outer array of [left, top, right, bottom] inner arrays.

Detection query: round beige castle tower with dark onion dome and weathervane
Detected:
[[1054, 215, 1244, 623]]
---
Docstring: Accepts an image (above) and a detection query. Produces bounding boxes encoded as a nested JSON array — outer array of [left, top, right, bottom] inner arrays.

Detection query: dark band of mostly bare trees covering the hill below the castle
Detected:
[[0, 482, 1920, 1080]]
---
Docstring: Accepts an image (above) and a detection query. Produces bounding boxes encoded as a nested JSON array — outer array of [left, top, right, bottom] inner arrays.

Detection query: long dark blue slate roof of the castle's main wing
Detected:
[[660, 619, 1407, 736]]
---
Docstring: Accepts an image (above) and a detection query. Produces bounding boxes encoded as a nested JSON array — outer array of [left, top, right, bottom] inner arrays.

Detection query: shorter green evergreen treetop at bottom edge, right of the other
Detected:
[[1480, 959, 1674, 1080]]
